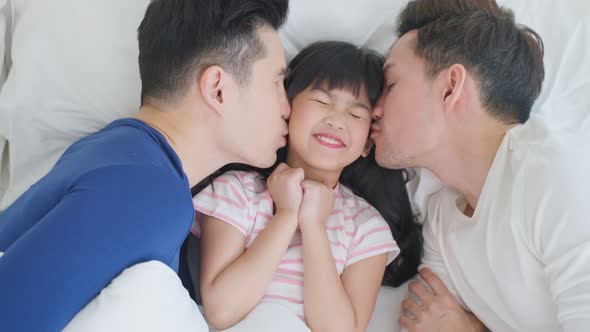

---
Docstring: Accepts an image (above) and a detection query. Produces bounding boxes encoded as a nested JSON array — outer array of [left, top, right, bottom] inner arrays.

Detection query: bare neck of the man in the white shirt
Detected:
[[426, 124, 513, 211]]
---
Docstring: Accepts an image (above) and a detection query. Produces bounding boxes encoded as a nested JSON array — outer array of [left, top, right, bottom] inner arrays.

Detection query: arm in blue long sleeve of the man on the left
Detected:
[[0, 166, 193, 331]]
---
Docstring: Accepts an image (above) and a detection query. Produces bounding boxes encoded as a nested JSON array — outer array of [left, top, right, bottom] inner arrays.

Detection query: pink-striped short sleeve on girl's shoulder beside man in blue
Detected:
[[192, 171, 253, 237]]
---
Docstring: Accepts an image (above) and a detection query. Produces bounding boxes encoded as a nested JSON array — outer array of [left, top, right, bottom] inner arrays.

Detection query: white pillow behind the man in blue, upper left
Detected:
[[0, 0, 149, 211]]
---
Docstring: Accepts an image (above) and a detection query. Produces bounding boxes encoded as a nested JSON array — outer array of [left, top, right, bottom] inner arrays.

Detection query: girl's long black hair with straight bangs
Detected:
[[197, 41, 422, 287]]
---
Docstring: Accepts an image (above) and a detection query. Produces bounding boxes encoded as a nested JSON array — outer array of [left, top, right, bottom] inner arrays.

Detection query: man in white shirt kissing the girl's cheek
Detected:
[[372, 0, 590, 331]]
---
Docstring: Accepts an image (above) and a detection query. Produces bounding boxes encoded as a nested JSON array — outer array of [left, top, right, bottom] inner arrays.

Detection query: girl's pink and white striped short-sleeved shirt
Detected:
[[192, 171, 399, 320]]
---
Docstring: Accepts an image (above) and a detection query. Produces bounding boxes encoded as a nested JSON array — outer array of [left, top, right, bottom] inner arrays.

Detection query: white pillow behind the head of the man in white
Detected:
[[498, 0, 590, 128]]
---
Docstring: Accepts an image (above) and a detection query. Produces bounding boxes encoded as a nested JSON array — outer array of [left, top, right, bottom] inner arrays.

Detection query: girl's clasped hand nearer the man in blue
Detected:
[[267, 163, 304, 216]]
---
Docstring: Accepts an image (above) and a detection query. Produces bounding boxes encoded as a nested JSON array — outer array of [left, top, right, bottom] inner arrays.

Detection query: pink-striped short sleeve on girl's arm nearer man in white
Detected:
[[344, 207, 400, 269]]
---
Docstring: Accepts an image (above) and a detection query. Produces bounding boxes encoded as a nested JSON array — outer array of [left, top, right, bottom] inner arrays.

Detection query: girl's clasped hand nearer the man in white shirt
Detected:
[[299, 180, 335, 231]]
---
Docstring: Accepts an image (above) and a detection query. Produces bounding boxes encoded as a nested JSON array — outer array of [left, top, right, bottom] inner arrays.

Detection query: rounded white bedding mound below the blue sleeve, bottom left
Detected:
[[64, 261, 208, 332]]
